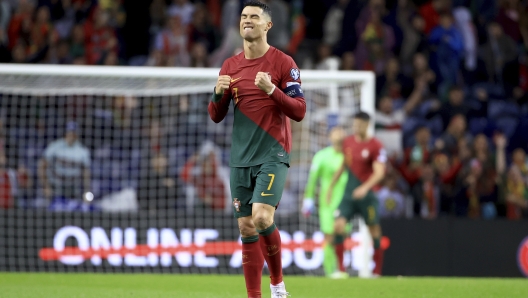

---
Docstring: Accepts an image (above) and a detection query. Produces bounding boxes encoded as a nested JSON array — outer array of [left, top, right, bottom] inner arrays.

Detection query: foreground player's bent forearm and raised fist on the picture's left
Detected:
[[207, 66, 231, 123]]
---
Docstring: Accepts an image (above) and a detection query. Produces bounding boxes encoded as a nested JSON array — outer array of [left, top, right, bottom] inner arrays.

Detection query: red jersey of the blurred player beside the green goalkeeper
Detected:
[[343, 136, 387, 183]]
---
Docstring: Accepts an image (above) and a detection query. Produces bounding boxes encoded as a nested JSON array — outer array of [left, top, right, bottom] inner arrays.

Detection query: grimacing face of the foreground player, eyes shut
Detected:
[[240, 6, 273, 41]]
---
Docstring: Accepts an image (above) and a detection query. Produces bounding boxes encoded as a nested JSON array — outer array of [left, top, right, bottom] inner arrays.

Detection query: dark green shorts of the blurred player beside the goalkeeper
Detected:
[[335, 175, 379, 226]]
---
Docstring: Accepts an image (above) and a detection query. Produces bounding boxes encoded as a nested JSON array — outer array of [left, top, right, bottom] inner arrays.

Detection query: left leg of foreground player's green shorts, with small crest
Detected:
[[229, 167, 255, 218]]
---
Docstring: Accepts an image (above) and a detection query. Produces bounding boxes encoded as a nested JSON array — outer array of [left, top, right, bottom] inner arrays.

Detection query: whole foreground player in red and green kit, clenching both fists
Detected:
[[209, 1, 306, 298]]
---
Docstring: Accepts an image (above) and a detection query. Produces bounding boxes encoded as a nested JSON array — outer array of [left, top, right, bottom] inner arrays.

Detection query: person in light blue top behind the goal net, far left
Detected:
[[39, 122, 91, 211]]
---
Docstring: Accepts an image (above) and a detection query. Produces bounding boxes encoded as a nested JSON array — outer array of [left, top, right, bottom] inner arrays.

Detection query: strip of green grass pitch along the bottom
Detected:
[[0, 273, 528, 298]]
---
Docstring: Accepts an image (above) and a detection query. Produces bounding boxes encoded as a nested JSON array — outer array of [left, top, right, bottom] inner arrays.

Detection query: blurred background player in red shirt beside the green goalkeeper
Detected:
[[327, 112, 387, 277]]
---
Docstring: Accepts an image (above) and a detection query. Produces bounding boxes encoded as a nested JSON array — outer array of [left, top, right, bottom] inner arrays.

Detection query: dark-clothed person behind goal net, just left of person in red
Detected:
[[138, 153, 185, 212]]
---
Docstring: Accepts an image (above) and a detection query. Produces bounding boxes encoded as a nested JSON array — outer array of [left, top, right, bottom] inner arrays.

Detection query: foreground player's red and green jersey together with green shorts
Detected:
[[208, 47, 306, 217]]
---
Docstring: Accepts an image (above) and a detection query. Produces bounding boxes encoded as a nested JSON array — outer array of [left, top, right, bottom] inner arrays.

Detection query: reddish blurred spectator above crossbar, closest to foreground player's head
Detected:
[[155, 16, 190, 66]]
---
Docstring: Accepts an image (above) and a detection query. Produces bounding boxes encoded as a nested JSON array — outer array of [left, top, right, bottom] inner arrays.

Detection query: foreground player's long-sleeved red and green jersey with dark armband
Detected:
[[209, 47, 306, 167]]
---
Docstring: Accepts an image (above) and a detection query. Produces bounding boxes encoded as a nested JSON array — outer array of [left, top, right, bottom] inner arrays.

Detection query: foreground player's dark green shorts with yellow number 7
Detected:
[[230, 162, 288, 218]]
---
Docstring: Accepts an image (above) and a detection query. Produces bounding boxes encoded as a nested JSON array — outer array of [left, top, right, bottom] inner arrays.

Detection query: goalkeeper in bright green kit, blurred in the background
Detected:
[[302, 126, 348, 277]]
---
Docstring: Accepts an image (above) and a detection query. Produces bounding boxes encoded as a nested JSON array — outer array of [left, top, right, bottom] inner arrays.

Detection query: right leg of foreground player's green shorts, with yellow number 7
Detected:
[[251, 163, 288, 207]]
